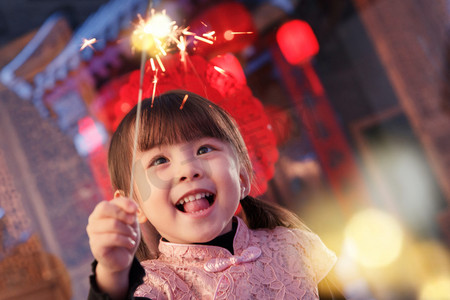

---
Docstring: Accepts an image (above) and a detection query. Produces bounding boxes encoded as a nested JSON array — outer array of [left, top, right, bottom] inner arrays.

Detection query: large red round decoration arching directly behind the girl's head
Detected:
[[98, 55, 278, 196]]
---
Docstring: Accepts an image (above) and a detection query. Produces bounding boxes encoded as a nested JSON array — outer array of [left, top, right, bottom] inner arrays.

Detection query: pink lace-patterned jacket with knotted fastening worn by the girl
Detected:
[[135, 218, 336, 300]]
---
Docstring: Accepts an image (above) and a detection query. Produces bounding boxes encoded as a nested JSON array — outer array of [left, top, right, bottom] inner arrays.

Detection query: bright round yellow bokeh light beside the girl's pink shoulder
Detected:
[[345, 209, 403, 268]]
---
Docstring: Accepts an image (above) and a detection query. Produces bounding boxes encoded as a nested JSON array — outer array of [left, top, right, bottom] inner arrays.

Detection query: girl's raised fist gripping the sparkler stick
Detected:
[[86, 197, 140, 275]]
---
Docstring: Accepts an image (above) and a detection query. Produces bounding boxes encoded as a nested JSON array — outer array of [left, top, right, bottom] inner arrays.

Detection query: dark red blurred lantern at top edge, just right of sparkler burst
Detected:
[[189, 1, 256, 58]]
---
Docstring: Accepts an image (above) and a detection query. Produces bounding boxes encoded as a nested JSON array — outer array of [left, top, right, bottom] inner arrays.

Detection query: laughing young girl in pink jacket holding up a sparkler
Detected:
[[87, 91, 336, 299]]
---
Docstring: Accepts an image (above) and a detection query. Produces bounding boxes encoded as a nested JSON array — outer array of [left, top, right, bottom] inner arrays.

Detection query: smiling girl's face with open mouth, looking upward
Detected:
[[134, 137, 249, 244]]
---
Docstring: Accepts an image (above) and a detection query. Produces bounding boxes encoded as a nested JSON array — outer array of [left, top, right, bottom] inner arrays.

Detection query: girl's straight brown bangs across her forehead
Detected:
[[138, 92, 235, 151]]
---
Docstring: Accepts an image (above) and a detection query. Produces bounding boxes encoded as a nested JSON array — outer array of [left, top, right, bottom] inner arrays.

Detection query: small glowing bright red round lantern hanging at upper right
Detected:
[[277, 20, 319, 65]]
